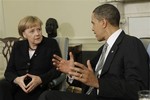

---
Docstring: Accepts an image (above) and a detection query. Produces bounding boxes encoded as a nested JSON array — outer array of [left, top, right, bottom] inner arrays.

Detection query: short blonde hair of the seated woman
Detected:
[[18, 16, 43, 37]]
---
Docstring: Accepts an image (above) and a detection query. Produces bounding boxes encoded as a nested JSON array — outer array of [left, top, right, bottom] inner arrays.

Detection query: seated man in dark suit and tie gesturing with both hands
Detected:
[[40, 4, 149, 100]]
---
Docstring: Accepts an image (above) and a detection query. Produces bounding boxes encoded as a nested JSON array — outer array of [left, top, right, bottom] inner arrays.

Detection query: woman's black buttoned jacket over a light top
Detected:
[[5, 37, 61, 87]]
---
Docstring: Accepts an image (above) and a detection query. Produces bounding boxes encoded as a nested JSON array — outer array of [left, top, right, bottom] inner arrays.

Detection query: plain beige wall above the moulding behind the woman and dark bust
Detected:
[[3, 0, 99, 38]]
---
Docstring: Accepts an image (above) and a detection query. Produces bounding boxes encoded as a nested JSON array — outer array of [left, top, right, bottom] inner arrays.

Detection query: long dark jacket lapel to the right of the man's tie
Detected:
[[101, 31, 125, 76]]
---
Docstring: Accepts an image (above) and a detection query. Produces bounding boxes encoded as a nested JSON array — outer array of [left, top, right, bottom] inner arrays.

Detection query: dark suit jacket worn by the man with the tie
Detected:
[[83, 31, 149, 100]]
